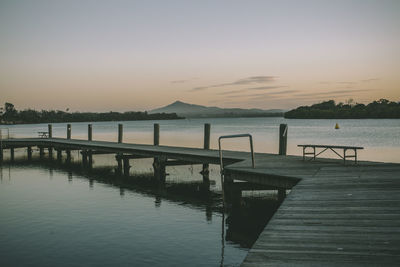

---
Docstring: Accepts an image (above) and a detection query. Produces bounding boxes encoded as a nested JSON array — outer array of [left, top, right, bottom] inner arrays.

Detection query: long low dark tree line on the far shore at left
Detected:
[[0, 103, 183, 124]]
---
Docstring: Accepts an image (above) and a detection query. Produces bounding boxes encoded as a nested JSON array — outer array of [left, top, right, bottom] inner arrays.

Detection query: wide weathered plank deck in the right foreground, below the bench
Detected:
[[242, 162, 400, 267]]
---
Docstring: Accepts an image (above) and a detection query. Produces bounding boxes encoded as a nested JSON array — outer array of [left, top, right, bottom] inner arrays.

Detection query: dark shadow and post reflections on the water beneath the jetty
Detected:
[[0, 158, 280, 251]]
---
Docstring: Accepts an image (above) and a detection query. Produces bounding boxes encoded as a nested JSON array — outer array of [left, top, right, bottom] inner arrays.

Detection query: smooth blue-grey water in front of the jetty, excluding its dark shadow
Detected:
[[0, 164, 268, 266]]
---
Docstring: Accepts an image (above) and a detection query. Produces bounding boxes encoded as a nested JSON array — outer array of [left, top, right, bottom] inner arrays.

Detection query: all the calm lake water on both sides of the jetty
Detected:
[[0, 118, 400, 266]]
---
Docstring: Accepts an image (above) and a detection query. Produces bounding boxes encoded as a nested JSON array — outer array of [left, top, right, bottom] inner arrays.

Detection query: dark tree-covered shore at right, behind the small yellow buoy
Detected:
[[284, 99, 400, 119]]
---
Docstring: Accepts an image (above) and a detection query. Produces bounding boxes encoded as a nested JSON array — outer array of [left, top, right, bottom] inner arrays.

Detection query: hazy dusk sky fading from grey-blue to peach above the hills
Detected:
[[0, 0, 400, 111]]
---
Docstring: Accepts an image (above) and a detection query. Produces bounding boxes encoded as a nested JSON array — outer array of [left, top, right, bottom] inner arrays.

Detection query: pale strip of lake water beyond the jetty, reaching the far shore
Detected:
[[2, 118, 400, 162]]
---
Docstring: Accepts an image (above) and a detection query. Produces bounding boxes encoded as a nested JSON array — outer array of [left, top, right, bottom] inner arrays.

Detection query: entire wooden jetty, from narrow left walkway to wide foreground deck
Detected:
[[1, 123, 400, 267]]
